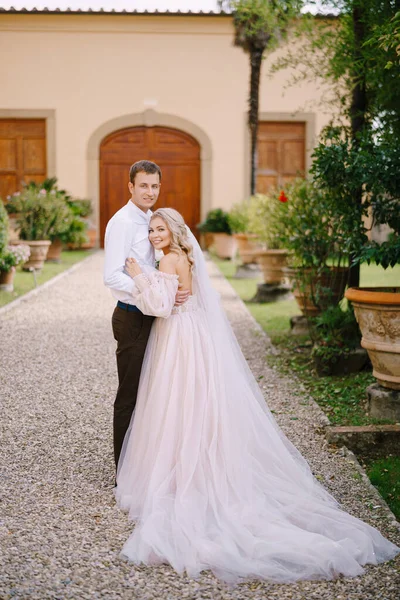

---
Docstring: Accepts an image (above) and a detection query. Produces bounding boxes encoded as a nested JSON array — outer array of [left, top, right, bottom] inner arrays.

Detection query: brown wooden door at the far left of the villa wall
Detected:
[[0, 119, 47, 201]]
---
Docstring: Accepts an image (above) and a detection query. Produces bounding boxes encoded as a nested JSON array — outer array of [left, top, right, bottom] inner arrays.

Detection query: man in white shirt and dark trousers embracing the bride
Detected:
[[104, 160, 189, 474]]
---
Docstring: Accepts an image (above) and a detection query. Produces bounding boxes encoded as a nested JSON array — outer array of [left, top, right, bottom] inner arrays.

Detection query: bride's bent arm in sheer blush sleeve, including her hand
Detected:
[[125, 255, 178, 318]]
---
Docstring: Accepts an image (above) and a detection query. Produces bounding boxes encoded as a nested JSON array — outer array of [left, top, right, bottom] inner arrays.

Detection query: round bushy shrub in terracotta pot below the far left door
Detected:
[[6, 185, 69, 270]]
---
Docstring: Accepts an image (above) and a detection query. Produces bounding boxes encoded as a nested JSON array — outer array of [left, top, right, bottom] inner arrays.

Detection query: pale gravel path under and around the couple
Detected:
[[0, 252, 400, 600]]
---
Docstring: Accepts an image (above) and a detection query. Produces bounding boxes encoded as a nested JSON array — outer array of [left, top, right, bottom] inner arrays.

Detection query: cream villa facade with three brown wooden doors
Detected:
[[0, 11, 330, 245]]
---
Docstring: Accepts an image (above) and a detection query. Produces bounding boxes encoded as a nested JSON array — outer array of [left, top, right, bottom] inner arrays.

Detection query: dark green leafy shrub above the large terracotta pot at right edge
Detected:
[[311, 128, 400, 269]]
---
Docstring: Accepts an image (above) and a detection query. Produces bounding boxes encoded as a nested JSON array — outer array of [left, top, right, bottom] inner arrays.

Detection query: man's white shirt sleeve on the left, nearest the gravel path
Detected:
[[104, 220, 136, 294]]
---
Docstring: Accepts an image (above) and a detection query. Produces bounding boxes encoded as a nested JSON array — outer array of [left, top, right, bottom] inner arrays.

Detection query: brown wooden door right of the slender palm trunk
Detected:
[[256, 121, 306, 193]]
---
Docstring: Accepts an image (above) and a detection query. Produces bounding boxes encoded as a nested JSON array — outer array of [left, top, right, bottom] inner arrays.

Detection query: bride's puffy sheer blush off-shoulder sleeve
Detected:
[[133, 272, 179, 319]]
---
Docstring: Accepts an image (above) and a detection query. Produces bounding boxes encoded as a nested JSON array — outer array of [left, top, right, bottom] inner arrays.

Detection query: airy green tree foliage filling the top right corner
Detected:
[[273, 0, 400, 140]]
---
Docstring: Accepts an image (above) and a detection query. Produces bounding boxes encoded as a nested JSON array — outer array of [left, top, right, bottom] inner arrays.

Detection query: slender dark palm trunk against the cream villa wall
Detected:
[[248, 50, 263, 195]]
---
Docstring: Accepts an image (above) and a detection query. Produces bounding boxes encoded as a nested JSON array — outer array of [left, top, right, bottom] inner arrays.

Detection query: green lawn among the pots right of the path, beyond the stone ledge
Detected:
[[212, 256, 400, 425]]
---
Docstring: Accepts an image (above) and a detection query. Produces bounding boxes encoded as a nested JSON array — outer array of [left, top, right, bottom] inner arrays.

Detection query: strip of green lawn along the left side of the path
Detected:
[[0, 250, 92, 306]]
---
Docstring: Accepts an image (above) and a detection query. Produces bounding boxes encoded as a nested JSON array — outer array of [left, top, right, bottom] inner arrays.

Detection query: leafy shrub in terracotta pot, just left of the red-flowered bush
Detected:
[[249, 190, 288, 286]]
